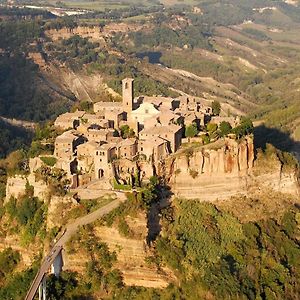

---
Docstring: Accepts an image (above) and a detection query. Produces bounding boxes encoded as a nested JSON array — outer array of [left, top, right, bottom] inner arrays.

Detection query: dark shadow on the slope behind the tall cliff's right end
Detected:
[[254, 125, 300, 154]]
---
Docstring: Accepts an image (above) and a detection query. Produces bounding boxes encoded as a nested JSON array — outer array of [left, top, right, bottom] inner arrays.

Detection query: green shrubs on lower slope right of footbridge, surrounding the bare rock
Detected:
[[56, 198, 300, 300]]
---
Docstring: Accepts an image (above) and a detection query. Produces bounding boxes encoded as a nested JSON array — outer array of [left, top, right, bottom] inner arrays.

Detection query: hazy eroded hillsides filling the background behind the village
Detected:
[[0, 0, 300, 157]]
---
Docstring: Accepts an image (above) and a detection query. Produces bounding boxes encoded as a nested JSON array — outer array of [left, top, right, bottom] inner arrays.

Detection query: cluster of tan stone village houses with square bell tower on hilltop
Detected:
[[54, 78, 239, 188]]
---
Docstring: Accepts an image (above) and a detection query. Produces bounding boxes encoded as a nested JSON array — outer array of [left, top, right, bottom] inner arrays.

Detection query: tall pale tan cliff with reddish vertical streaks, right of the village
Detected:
[[163, 137, 299, 201]]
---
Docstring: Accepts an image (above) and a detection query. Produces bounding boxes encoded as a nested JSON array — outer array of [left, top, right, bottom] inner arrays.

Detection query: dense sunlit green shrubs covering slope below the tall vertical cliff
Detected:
[[152, 199, 300, 299]]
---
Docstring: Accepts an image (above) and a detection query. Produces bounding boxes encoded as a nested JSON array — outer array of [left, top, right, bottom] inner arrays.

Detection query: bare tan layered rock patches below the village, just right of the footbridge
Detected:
[[64, 213, 176, 288]]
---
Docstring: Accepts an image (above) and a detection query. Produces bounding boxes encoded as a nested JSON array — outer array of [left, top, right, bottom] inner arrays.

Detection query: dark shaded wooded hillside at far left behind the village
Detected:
[[0, 20, 72, 157]]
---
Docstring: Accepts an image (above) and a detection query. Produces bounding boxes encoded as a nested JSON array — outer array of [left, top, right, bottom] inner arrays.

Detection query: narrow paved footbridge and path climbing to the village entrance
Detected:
[[25, 192, 126, 300]]
